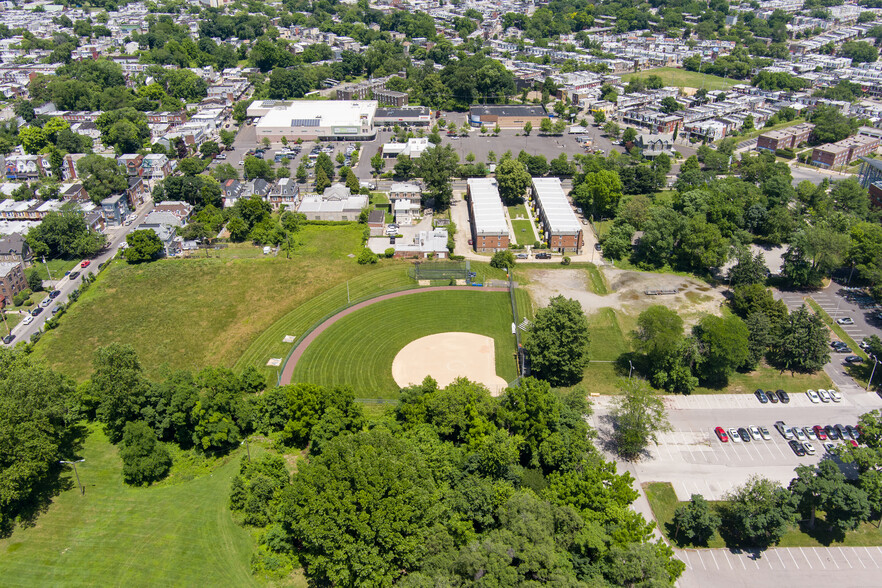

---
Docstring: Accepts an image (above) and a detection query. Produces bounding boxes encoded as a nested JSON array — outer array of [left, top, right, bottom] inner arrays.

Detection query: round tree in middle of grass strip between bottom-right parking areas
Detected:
[[723, 476, 795, 548]]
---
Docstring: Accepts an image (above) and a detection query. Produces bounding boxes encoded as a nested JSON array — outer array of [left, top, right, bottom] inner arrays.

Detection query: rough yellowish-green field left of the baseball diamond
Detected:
[[35, 225, 382, 380]]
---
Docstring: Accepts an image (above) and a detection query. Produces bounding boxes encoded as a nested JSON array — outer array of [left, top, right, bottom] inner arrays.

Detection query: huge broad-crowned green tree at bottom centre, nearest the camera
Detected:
[[277, 428, 444, 586]]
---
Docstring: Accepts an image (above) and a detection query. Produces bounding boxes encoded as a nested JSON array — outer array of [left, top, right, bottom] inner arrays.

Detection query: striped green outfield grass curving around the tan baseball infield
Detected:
[[293, 290, 531, 398]]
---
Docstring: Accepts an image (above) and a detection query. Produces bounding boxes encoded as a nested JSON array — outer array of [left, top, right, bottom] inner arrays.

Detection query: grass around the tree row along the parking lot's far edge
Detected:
[[581, 308, 832, 394]]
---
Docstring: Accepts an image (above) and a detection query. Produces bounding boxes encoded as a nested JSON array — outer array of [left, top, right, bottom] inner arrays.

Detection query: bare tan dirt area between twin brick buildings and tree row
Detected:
[[525, 266, 725, 322]]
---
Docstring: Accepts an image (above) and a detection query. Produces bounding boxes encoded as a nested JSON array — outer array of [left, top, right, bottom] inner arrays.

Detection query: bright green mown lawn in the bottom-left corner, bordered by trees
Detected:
[[0, 427, 258, 587]]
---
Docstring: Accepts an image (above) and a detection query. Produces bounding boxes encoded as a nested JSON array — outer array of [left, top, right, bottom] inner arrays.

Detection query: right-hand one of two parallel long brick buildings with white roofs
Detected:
[[530, 178, 585, 253]]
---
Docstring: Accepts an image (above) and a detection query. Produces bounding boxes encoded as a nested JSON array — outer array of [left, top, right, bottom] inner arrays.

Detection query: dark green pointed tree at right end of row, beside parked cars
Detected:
[[773, 304, 830, 373]]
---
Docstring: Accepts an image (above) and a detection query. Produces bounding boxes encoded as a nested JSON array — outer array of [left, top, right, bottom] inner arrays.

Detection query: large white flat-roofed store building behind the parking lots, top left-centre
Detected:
[[247, 100, 377, 143]]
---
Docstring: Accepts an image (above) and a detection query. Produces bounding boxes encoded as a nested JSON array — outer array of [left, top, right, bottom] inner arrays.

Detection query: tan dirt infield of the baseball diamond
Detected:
[[392, 333, 508, 396]]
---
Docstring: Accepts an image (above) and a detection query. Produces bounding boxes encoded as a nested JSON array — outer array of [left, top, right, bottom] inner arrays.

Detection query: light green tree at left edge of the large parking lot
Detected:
[[610, 378, 671, 459]]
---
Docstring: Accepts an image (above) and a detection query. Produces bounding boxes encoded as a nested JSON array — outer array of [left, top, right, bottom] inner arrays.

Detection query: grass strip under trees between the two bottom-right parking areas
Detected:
[[643, 482, 882, 548]]
